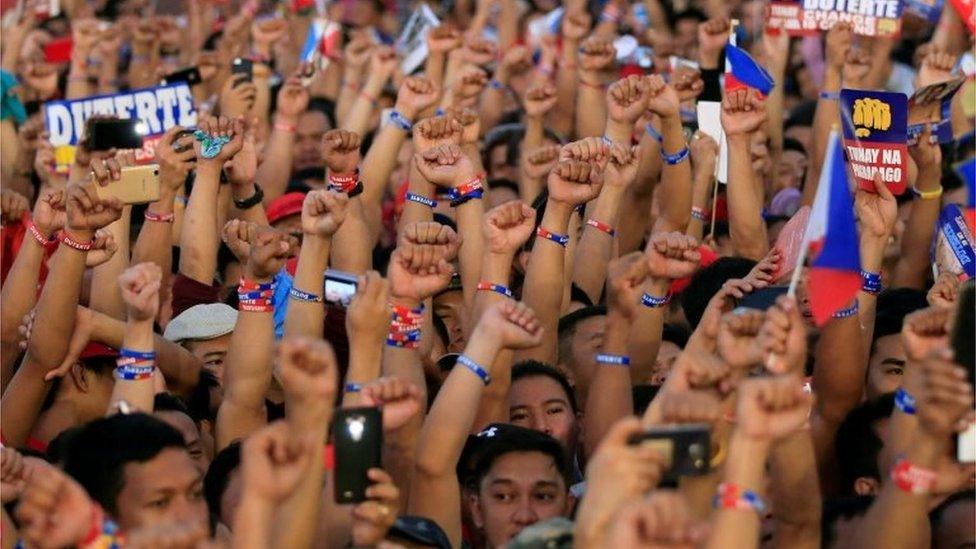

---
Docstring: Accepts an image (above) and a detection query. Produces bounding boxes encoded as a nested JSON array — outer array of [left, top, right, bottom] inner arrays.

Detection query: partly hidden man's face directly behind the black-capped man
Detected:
[[508, 376, 577, 451]]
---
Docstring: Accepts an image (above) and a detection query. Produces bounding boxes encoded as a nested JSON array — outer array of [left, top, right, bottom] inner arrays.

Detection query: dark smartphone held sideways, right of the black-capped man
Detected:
[[628, 423, 712, 481]]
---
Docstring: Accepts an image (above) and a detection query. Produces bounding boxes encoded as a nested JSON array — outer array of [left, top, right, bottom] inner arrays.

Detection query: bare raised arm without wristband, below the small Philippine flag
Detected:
[[722, 89, 769, 261]]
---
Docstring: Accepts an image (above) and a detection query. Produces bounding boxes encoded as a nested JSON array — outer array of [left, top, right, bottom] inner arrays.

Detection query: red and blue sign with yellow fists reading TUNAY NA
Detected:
[[840, 89, 908, 195]]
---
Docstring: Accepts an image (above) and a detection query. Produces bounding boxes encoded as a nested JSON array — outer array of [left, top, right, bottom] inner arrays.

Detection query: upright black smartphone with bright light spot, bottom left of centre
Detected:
[[332, 407, 383, 503]]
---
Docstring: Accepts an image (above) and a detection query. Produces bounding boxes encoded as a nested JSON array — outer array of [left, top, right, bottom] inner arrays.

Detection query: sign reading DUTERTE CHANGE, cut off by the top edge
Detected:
[[766, 0, 902, 36]]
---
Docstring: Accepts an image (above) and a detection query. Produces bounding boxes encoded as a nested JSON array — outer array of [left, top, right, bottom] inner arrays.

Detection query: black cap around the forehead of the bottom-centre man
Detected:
[[465, 425, 572, 492]]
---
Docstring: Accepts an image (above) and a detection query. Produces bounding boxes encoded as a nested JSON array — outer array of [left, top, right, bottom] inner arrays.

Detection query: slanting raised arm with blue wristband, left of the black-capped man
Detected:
[[407, 301, 542, 547]]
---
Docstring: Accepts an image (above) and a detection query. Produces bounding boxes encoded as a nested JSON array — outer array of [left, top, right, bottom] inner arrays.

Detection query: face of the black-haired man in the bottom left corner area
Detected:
[[116, 448, 207, 530]]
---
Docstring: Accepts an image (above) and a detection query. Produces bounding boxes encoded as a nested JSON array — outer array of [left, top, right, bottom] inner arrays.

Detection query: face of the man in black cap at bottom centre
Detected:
[[471, 452, 569, 547]]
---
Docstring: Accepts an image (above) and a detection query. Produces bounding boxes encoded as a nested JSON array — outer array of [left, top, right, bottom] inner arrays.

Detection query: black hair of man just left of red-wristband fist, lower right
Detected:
[[835, 393, 895, 494]]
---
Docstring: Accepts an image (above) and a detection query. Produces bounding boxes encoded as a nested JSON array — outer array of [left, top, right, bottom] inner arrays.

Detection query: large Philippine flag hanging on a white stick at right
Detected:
[[797, 129, 861, 326]]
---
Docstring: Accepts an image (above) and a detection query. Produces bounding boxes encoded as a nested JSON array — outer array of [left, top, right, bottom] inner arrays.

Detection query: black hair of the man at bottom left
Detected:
[[63, 413, 186, 515]]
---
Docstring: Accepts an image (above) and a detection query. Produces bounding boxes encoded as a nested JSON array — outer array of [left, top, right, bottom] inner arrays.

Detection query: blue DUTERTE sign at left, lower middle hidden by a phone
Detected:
[[44, 82, 197, 173]]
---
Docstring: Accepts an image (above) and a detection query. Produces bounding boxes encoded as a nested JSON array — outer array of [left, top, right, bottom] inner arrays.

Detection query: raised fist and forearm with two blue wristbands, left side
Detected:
[[108, 263, 163, 414]]
